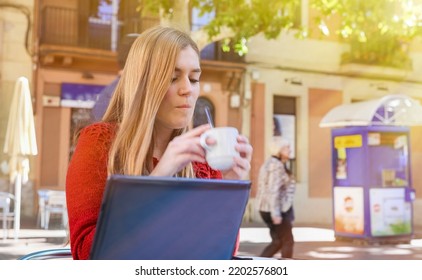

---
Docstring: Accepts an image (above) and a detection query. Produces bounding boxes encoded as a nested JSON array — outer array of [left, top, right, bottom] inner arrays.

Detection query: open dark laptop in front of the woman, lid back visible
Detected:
[[90, 175, 251, 260]]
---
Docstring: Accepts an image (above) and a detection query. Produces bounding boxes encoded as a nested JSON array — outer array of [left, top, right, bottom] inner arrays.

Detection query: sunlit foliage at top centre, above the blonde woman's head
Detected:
[[140, 0, 302, 55]]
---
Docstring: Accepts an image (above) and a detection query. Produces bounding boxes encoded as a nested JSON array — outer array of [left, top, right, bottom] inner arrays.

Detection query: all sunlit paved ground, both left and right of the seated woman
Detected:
[[0, 217, 422, 260]]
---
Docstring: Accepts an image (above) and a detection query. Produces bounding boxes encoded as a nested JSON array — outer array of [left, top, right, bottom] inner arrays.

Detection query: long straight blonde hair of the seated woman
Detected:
[[103, 26, 199, 177]]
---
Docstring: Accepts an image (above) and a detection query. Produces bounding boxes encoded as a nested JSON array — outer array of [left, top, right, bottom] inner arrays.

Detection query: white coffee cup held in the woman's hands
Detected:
[[200, 127, 239, 170]]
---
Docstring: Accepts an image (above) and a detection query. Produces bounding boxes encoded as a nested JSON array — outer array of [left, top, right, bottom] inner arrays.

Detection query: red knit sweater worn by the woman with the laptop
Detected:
[[66, 123, 239, 259]]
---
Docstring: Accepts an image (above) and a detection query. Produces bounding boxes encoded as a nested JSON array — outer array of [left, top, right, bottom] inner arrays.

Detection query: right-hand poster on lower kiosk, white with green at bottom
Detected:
[[369, 188, 412, 236]]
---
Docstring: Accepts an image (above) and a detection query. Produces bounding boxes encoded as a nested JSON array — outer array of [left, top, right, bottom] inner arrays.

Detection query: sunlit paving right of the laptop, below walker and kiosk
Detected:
[[240, 224, 422, 260]]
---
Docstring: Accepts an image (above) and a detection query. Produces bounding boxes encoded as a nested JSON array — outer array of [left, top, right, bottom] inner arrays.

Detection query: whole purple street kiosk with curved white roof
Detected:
[[320, 95, 422, 243]]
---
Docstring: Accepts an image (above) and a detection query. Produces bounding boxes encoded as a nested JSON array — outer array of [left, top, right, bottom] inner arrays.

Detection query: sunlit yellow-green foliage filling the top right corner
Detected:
[[310, 0, 422, 68]]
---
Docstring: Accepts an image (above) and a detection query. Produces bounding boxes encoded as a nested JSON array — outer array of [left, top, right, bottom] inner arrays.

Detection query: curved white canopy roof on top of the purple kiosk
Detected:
[[319, 95, 422, 127]]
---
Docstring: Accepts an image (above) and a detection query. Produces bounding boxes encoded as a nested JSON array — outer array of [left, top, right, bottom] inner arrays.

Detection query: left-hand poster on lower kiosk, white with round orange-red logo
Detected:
[[334, 187, 364, 235]]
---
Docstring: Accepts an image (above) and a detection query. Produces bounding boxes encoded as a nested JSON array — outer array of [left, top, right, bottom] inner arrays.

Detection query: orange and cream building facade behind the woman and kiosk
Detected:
[[0, 0, 422, 230]]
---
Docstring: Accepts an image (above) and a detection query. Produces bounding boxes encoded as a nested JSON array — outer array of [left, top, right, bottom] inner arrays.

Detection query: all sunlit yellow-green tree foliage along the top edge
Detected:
[[139, 0, 422, 68]]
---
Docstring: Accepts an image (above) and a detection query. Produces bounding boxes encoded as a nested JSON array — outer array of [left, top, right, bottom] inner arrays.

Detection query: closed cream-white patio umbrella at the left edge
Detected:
[[3, 77, 38, 239]]
